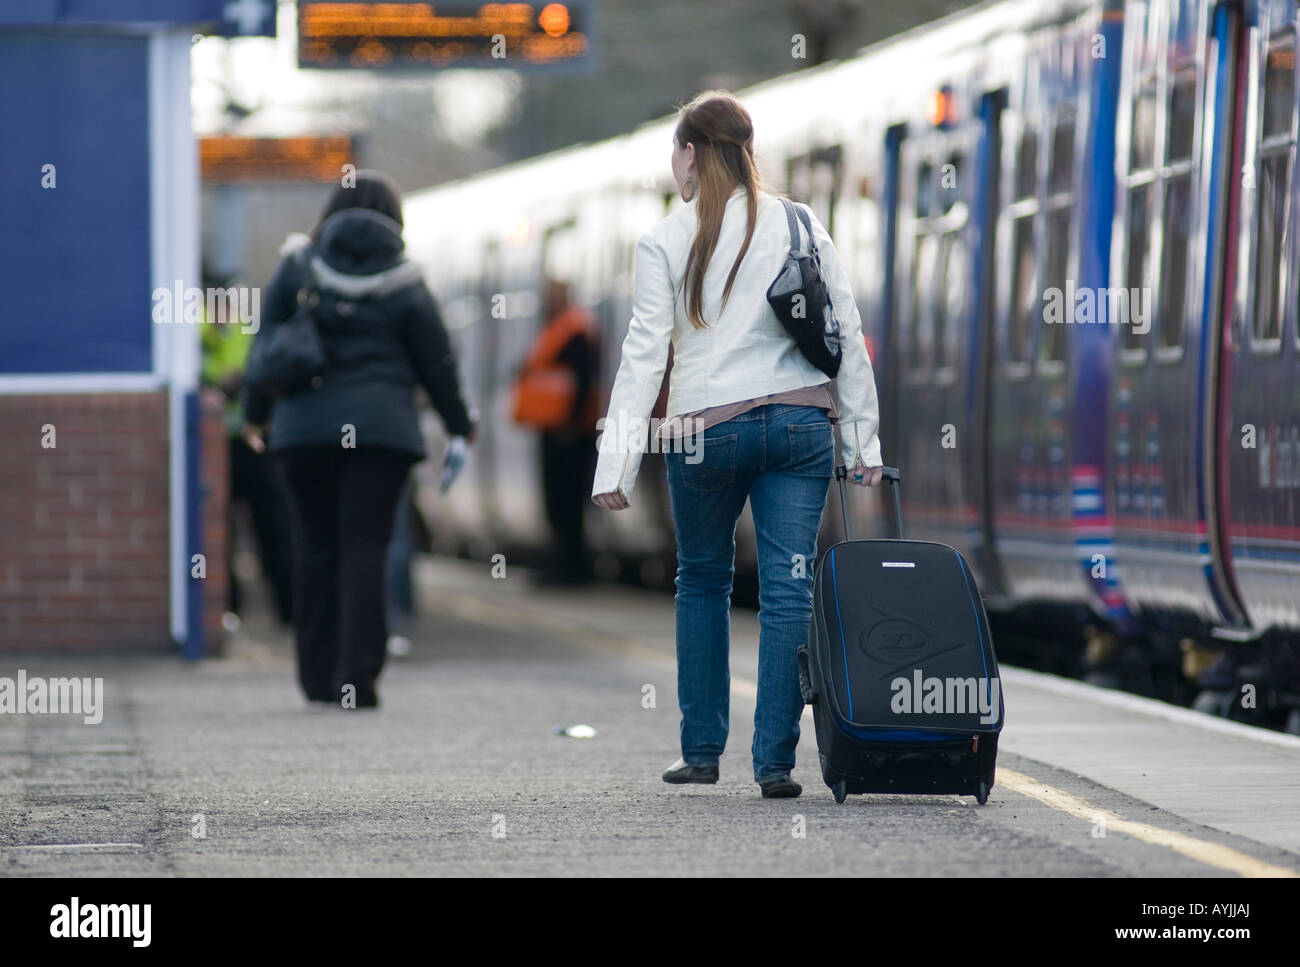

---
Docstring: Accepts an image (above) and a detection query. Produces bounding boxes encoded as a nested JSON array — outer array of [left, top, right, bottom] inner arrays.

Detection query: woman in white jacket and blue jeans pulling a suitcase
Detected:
[[592, 91, 881, 798]]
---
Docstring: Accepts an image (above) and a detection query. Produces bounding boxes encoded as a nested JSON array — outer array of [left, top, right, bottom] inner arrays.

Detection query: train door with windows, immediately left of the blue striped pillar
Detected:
[[989, 26, 1105, 604]]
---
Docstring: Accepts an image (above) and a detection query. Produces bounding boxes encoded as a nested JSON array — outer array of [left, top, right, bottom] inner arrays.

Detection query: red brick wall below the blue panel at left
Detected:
[[0, 391, 225, 650]]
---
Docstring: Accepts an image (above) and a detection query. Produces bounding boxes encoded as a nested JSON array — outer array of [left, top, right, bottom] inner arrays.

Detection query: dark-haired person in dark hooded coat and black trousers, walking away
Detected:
[[244, 170, 475, 708]]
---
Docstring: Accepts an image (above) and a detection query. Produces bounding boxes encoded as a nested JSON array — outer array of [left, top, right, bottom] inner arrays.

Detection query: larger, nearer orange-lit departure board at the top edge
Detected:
[[298, 0, 593, 70]]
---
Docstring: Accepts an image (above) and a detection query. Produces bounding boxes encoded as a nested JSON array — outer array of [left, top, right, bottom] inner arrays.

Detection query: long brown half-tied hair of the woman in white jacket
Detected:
[[675, 91, 759, 329]]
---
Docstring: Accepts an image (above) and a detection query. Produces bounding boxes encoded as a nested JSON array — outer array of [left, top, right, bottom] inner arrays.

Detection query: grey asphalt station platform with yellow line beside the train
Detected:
[[0, 559, 1300, 877]]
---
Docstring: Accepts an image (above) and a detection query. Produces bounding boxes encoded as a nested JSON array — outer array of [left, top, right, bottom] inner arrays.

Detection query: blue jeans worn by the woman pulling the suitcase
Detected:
[[666, 404, 835, 781]]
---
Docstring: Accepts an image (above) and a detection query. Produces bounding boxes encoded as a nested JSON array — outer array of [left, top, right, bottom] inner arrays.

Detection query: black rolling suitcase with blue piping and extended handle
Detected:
[[800, 467, 1002, 805]]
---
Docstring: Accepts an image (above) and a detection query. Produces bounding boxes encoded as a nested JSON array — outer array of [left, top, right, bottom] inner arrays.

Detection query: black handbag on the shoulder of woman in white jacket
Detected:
[[767, 198, 844, 380]]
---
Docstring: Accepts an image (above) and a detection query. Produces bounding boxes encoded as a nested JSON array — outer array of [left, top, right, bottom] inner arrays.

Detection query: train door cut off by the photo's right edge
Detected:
[[1205, 0, 1300, 637]]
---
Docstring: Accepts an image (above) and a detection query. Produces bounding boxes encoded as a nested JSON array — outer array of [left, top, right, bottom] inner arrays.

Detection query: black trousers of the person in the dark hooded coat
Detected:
[[278, 446, 416, 707]]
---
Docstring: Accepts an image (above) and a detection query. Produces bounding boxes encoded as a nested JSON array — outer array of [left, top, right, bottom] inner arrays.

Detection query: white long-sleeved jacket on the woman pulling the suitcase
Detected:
[[592, 188, 880, 499]]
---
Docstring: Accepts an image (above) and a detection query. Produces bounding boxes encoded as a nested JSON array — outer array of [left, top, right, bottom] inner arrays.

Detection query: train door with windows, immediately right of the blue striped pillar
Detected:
[[1108, 0, 1227, 636]]
